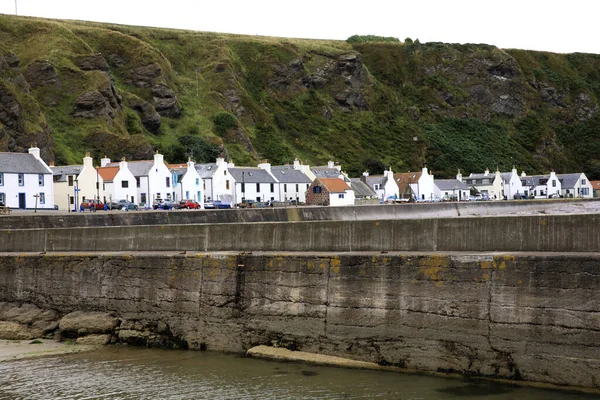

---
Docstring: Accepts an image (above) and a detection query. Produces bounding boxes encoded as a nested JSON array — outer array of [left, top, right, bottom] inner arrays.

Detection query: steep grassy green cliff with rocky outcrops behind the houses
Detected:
[[0, 15, 600, 178]]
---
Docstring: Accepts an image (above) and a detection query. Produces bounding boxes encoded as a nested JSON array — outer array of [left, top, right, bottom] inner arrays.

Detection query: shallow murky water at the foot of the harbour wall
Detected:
[[0, 347, 600, 400]]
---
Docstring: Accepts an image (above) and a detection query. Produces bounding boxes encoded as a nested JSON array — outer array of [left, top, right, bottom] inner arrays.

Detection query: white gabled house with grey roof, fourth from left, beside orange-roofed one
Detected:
[[102, 152, 175, 207]]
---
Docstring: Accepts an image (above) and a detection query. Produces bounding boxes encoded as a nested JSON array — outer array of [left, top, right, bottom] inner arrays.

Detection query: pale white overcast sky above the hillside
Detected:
[[0, 0, 600, 54]]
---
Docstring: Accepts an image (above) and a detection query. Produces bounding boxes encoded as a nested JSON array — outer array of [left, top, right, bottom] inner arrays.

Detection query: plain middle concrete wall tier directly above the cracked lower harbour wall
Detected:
[[0, 214, 600, 252]]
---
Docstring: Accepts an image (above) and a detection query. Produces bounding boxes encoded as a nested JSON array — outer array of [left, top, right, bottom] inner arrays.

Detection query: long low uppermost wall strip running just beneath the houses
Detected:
[[0, 199, 600, 229]]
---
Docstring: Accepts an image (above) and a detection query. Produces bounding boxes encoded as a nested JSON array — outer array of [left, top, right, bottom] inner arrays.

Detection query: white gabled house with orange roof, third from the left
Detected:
[[98, 158, 138, 203]]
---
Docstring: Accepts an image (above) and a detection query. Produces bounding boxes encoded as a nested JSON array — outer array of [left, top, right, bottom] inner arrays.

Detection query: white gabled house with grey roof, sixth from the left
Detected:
[[195, 157, 235, 204]]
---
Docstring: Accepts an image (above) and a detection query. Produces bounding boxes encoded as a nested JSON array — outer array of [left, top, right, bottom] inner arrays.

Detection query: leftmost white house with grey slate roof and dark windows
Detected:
[[0, 147, 54, 210]]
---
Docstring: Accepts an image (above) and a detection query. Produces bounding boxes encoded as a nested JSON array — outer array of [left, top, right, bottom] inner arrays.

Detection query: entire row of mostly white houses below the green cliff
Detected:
[[0, 147, 594, 210]]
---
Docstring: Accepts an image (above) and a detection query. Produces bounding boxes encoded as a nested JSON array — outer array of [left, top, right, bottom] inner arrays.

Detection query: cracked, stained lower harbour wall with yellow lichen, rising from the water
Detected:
[[0, 253, 600, 388]]
